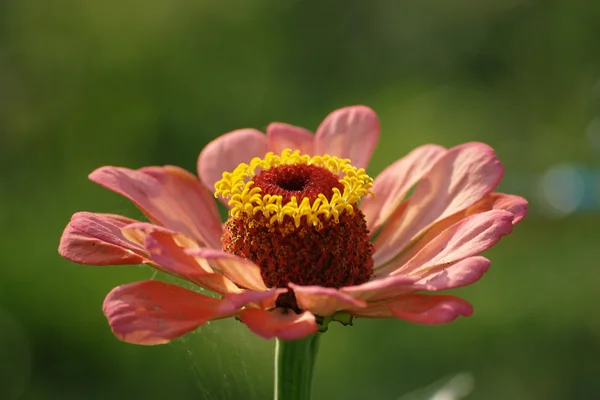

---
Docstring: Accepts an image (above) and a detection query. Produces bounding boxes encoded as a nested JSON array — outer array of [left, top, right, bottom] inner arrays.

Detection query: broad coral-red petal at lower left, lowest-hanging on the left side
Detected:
[[102, 281, 221, 345]]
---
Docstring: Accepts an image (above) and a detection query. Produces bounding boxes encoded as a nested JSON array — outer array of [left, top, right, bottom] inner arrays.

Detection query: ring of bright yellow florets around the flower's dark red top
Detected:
[[215, 149, 373, 227]]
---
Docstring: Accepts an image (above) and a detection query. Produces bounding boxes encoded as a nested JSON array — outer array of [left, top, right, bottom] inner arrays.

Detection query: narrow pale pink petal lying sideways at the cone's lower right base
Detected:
[[340, 275, 420, 300]]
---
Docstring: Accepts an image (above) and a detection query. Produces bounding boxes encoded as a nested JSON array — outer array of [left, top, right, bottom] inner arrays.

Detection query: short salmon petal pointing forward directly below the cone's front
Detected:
[[289, 283, 367, 317]]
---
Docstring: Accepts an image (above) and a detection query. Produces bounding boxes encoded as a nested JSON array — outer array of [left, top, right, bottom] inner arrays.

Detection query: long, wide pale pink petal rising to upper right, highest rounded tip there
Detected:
[[373, 143, 504, 267]]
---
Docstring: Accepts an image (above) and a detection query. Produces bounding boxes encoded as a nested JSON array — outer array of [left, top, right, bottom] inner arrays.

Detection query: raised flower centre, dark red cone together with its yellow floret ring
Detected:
[[215, 149, 373, 312]]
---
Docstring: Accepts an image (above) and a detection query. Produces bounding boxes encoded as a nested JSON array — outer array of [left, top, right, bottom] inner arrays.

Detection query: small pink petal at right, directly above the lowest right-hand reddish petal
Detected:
[[413, 256, 490, 291]]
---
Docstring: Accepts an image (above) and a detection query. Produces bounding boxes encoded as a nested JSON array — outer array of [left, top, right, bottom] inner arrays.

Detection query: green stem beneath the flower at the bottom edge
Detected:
[[274, 333, 321, 400]]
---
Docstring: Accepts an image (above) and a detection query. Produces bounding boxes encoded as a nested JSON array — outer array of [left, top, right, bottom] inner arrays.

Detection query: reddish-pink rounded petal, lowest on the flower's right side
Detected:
[[388, 294, 473, 325]]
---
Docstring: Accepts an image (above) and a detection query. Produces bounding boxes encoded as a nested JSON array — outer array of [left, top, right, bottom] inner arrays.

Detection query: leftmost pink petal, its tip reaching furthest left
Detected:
[[58, 212, 146, 265]]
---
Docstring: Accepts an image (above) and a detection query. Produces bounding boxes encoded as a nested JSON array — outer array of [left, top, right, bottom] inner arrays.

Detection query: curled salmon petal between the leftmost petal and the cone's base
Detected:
[[124, 223, 241, 294]]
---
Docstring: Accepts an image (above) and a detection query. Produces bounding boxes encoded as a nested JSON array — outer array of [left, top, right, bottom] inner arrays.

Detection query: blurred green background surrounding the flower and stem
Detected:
[[0, 0, 600, 400]]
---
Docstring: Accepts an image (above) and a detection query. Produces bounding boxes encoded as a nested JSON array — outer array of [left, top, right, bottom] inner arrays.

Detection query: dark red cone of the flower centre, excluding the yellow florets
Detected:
[[222, 164, 373, 311]]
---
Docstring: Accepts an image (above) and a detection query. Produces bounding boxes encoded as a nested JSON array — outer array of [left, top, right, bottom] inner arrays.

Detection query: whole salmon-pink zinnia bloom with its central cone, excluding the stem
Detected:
[[59, 106, 527, 344]]
